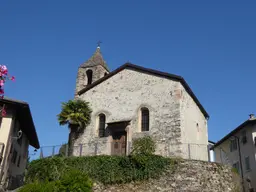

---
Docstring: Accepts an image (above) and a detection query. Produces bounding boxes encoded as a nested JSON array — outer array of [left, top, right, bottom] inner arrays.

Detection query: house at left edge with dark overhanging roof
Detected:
[[0, 99, 40, 189]]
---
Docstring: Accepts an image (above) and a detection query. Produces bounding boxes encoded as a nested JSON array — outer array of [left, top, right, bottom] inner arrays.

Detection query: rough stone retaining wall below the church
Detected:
[[94, 160, 241, 192]]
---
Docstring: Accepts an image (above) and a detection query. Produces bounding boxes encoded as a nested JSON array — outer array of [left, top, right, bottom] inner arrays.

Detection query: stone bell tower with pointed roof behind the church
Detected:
[[75, 44, 109, 96]]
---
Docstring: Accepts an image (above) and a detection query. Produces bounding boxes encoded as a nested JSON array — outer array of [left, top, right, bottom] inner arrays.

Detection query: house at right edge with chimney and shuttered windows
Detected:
[[212, 114, 256, 190]]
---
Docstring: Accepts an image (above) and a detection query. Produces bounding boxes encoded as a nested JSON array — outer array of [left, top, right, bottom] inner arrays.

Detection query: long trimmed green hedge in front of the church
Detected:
[[26, 155, 175, 184]]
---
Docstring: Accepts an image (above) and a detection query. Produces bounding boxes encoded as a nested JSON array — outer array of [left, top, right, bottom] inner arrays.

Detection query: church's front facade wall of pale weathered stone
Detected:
[[75, 69, 181, 155]]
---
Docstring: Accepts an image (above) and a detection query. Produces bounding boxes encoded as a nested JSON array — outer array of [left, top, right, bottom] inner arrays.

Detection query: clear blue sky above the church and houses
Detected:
[[0, 0, 256, 149]]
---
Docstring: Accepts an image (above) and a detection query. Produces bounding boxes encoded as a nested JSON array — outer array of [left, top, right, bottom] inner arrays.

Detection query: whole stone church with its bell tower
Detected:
[[73, 47, 209, 160]]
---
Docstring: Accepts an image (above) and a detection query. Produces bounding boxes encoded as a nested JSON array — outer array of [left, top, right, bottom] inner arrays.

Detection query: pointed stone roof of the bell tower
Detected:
[[80, 47, 109, 71]]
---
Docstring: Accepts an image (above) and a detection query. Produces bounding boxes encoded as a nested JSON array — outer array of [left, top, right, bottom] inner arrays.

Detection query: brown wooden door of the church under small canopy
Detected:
[[112, 132, 126, 155]]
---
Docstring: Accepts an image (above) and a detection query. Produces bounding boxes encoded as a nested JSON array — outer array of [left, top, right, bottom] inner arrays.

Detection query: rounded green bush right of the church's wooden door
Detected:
[[132, 136, 156, 155]]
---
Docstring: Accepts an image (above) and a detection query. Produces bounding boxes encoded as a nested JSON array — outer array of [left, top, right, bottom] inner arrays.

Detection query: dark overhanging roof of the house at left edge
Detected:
[[0, 97, 40, 149]]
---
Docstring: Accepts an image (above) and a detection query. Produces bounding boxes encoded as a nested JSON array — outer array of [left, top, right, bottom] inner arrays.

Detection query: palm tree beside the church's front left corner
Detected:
[[57, 99, 92, 155]]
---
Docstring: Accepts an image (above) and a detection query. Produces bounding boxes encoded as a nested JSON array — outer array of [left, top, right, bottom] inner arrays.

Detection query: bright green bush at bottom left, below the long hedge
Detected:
[[19, 169, 93, 192]]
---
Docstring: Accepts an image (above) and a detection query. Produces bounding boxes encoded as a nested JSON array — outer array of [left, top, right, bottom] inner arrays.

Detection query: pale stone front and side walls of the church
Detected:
[[74, 69, 208, 161]]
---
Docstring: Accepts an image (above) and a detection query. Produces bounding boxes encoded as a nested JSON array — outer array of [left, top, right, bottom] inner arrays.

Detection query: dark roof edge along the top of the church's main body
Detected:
[[78, 63, 209, 118]]
